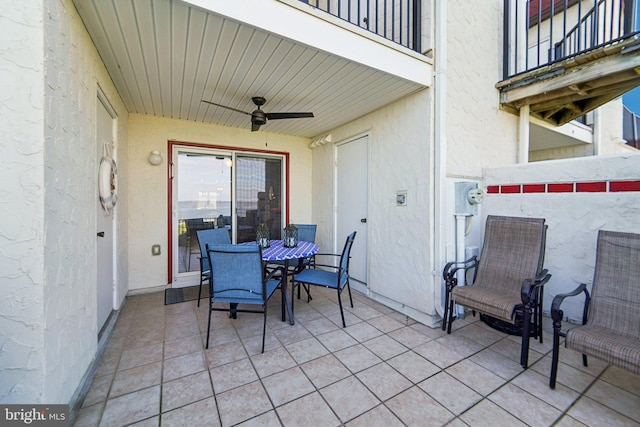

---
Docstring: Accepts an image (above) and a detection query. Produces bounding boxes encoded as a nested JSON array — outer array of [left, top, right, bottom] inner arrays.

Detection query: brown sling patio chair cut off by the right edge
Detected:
[[549, 230, 640, 389]]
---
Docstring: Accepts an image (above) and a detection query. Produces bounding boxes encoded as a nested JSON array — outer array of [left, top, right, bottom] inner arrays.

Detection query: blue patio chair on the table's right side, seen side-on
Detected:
[[291, 231, 356, 328]]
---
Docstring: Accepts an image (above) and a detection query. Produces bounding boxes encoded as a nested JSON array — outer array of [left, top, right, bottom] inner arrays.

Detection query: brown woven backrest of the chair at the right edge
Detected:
[[587, 230, 640, 338]]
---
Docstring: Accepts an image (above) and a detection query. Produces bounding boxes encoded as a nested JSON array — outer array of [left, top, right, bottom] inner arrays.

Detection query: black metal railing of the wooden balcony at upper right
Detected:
[[503, 0, 639, 79]]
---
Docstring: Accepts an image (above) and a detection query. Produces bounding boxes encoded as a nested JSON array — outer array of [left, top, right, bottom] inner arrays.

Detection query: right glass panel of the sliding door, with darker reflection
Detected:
[[236, 155, 284, 243]]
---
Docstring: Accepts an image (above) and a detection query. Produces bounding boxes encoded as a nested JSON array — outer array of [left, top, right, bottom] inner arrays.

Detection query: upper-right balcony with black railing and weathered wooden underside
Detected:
[[497, 0, 640, 125]]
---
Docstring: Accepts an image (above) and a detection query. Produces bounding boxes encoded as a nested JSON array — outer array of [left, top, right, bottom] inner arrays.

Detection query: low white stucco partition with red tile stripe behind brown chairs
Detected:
[[483, 154, 640, 320]]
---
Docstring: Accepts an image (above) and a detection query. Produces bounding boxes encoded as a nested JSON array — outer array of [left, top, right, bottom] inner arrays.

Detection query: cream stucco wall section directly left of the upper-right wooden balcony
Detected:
[[444, 0, 518, 178]]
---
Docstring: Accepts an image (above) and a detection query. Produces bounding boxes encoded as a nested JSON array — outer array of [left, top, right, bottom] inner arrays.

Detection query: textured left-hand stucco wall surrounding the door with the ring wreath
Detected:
[[43, 0, 127, 402]]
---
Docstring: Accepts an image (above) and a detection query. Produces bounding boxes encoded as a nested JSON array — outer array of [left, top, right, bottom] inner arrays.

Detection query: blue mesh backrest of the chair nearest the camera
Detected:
[[207, 244, 265, 302]]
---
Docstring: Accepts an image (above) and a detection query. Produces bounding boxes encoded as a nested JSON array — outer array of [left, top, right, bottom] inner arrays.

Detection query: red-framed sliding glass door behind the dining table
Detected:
[[171, 145, 286, 286]]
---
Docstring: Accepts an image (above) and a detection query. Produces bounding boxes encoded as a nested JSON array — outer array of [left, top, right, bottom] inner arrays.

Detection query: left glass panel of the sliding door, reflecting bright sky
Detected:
[[174, 151, 232, 274]]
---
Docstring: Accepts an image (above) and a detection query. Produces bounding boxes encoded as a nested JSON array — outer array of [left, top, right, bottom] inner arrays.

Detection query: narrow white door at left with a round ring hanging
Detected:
[[96, 99, 115, 331]]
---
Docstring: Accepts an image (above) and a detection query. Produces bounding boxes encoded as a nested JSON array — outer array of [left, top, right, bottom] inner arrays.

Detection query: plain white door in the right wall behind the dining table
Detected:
[[336, 135, 369, 293]]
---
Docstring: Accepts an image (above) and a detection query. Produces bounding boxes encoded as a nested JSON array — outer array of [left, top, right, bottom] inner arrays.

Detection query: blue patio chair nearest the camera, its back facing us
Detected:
[[206, 244, 282, 353]]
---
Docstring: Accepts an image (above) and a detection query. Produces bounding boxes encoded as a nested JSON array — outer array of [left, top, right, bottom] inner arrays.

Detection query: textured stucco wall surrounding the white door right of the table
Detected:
[[313, 91, 435, 323]]
